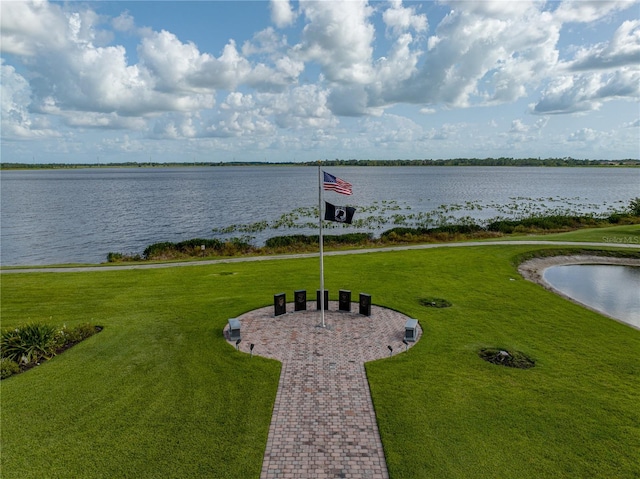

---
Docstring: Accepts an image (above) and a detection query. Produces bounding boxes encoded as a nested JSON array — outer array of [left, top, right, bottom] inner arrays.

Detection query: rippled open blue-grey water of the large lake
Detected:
[[0, 166, 640, 266]]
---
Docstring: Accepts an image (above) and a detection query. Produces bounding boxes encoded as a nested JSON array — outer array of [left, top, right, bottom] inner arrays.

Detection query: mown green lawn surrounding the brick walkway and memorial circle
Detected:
[[0, 245, 640, 479]]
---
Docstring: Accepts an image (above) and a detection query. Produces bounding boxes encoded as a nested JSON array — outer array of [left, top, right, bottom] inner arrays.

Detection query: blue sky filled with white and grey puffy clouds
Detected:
[[0, 0, 640, 163]]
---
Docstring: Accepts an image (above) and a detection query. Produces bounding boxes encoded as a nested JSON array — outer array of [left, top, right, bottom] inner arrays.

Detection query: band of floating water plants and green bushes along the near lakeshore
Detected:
[[108, 197, 640, 262]]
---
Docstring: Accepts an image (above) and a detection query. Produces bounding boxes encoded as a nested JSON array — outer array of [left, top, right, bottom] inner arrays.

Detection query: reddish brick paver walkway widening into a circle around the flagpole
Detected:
[[225, 301, 421, 479]]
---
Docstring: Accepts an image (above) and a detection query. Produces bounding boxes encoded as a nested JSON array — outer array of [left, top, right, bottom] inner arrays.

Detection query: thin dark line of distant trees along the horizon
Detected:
[[0, 158, 640, 170]]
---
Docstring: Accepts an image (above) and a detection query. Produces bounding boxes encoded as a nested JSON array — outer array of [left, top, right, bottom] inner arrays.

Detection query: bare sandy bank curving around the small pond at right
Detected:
[[518, 255, 640, 329]]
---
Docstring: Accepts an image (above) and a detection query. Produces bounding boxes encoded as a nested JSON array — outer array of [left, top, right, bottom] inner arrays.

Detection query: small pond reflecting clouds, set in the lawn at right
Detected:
[[543, 264, 640, 328]]
